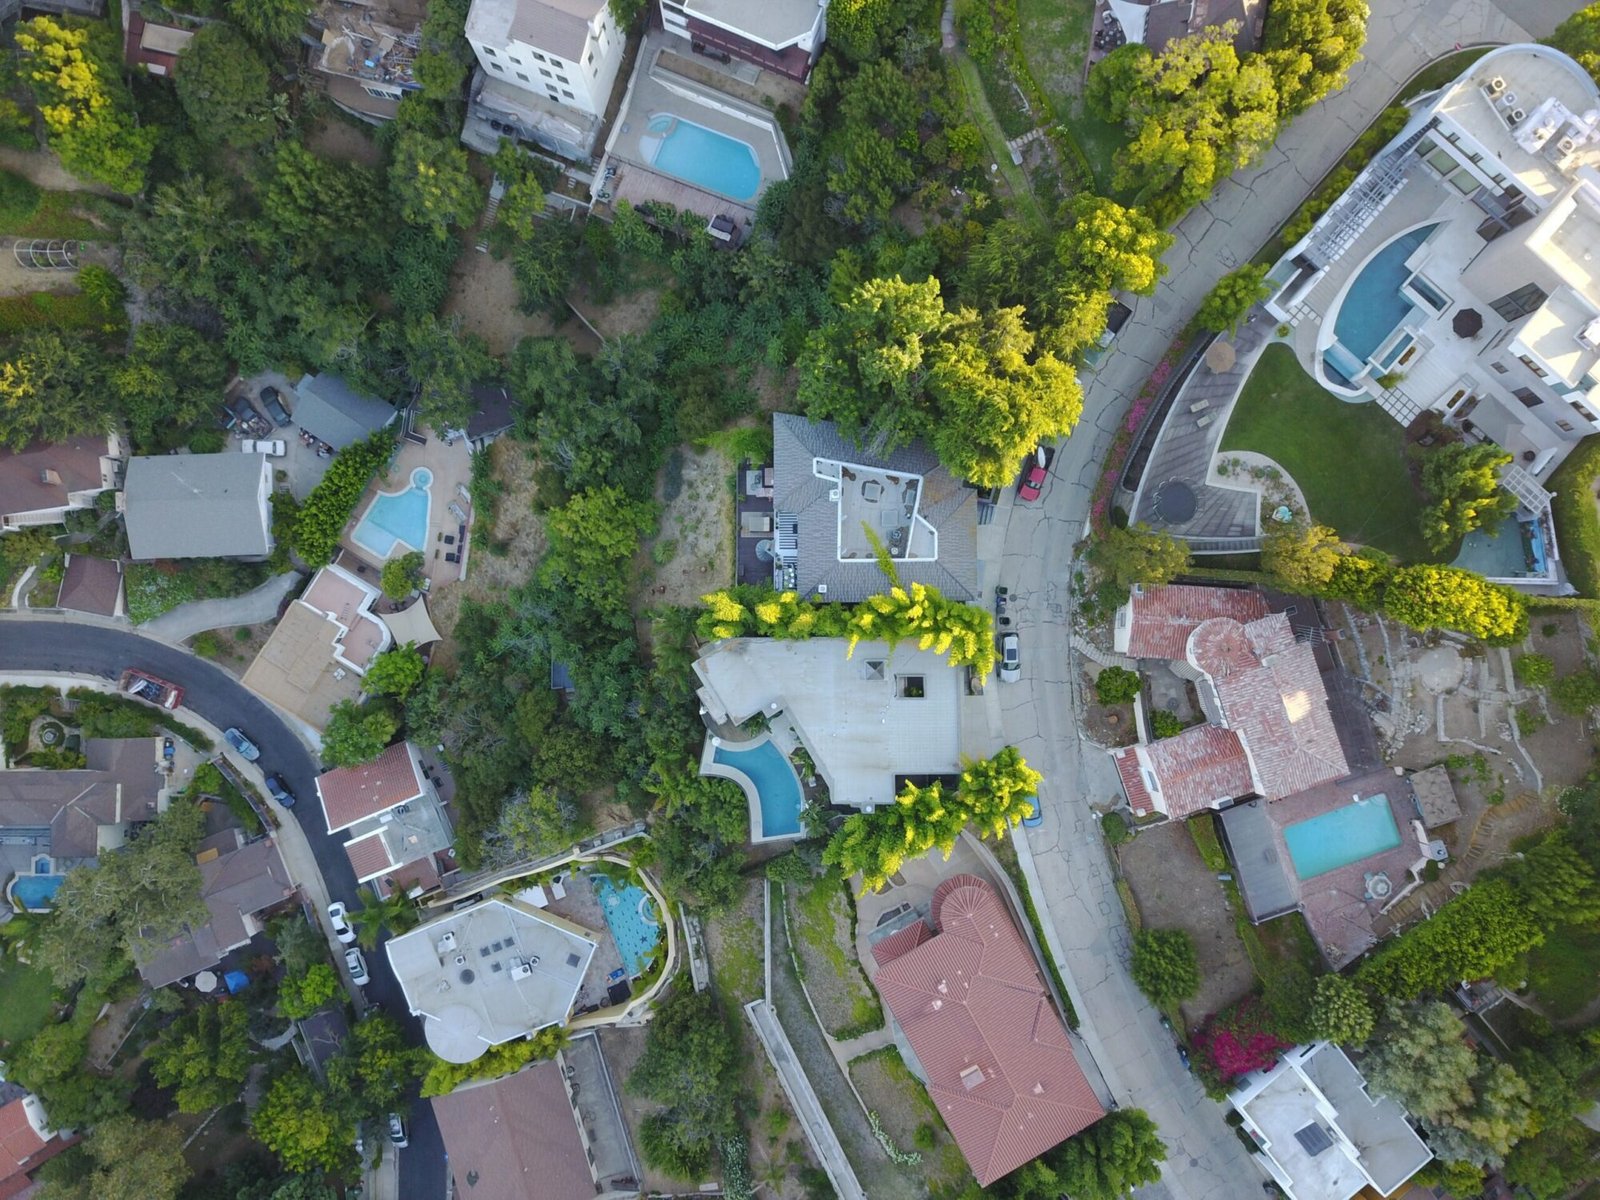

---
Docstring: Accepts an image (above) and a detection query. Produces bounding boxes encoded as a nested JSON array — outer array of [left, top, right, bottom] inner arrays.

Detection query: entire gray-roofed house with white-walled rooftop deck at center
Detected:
[[773, 413, 978, 603]]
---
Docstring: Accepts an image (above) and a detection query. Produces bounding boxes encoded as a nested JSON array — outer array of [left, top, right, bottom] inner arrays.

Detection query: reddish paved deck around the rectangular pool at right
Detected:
[[1267, 766, 1422, 970]]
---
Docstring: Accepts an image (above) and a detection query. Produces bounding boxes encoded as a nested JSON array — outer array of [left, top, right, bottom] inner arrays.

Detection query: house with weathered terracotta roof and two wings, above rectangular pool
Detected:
[[1112, 586, 1350, 818]]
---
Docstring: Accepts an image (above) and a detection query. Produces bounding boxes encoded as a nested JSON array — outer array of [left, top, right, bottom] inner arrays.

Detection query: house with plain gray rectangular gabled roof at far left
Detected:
[[122, 451, 272, 562]]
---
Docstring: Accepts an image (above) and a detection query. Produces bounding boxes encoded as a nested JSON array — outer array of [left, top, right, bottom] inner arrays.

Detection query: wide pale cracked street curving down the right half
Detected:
[[989, 0, 1578, 1200]]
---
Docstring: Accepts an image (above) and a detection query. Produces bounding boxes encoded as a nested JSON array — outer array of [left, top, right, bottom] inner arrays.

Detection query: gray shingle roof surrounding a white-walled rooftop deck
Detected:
[[773, 413, 978, 603]]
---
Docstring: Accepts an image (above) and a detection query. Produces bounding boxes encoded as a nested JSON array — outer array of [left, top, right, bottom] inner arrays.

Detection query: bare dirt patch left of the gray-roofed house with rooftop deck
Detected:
[[638, 450, 733, 620]]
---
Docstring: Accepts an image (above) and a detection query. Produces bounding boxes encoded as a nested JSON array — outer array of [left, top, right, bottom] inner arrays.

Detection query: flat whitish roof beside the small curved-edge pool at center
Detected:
[[694, 637, 966, 806]]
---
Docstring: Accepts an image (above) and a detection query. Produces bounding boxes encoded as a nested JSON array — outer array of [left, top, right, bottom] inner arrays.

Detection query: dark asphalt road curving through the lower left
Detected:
[[0, 618, 446, 1200]]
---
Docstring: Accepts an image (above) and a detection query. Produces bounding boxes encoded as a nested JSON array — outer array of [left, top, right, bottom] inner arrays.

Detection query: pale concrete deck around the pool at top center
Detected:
[[595, 30, 792, 226]]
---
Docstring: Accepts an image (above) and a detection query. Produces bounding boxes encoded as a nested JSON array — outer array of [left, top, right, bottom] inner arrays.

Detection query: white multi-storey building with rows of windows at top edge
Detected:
[[466, 0, 627, 117]]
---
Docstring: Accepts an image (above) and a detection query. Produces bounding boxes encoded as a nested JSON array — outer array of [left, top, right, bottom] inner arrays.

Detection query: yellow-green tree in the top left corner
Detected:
[[14, 16, 158, 195]]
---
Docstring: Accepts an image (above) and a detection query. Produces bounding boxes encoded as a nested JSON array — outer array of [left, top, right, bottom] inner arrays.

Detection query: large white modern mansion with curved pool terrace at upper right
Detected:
[[1266, 45, 1600, 512]]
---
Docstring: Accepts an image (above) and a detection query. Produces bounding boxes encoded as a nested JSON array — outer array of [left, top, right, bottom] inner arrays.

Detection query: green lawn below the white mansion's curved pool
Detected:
[[1221, 346, 1435, 563]]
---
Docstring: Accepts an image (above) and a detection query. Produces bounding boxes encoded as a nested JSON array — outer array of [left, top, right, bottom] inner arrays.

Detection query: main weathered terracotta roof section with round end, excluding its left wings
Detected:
[[1189, 613, 1350, 800]]
